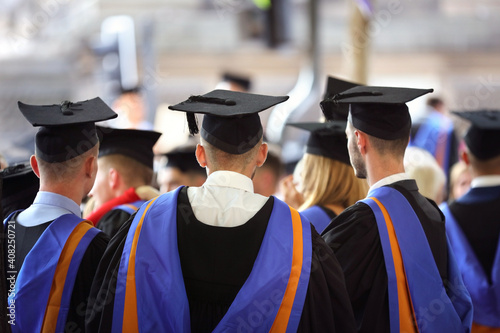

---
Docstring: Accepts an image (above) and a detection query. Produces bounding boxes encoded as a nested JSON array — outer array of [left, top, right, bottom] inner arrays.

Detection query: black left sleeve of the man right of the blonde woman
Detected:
[[322, 203, 390, 332]]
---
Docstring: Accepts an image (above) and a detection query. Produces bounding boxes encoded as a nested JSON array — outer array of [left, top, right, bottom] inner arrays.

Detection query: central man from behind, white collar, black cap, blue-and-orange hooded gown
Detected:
[[87, 90, 355, 332]]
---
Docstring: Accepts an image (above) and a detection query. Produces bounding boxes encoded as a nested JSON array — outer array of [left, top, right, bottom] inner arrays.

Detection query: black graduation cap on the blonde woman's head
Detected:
[[287, 121, 351, 165]]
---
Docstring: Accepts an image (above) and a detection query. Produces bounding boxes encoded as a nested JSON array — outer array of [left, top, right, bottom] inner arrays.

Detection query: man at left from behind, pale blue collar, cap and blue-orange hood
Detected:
[[4, 97, 116, 332]]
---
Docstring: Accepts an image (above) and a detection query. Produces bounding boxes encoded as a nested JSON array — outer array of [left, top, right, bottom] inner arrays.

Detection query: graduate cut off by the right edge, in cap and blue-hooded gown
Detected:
[[441, 110, 500, 332]]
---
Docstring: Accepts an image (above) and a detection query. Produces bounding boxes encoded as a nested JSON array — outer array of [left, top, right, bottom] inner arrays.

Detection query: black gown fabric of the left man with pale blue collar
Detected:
[[4, 213, 109, 332]]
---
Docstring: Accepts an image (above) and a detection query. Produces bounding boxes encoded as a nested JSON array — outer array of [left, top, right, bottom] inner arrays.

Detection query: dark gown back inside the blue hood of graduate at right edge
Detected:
[[450, 187, 500, 283]]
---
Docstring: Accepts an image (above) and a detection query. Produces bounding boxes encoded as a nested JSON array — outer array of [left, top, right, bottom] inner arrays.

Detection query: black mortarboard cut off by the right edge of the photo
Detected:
[[453, 110, 500, 160]]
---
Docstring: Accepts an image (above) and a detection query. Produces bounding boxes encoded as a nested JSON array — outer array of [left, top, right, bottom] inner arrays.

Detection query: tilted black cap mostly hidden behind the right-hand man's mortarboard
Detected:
[[319, 76, 359, 121]]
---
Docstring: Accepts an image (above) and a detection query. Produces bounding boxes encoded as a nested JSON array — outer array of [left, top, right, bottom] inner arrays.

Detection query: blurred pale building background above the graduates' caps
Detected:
[[0, 0, 500, 163]]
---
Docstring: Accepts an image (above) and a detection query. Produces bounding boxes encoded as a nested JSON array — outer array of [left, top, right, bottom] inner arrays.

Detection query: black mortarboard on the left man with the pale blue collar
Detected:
[[18, 97, 118, 163]]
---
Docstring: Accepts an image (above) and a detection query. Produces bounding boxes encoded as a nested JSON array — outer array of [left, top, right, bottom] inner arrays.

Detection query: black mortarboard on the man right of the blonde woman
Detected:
[[331, 86, 434, 140]]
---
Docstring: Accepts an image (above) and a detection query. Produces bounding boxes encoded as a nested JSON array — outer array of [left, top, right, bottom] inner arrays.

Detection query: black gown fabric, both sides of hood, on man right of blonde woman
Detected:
[[322, 180, 448, 332]]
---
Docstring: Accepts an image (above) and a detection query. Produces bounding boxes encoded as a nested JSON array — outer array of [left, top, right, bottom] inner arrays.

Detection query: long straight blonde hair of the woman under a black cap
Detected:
[[298, 154, 368, 210]]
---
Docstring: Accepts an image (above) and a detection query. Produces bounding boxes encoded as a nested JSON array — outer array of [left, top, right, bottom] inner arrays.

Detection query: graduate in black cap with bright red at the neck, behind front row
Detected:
[[86, 126, 161, 237]]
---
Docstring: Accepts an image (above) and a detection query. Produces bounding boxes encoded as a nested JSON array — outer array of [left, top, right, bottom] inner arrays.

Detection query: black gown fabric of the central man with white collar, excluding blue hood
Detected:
[[87, 188, 355, 332]]
